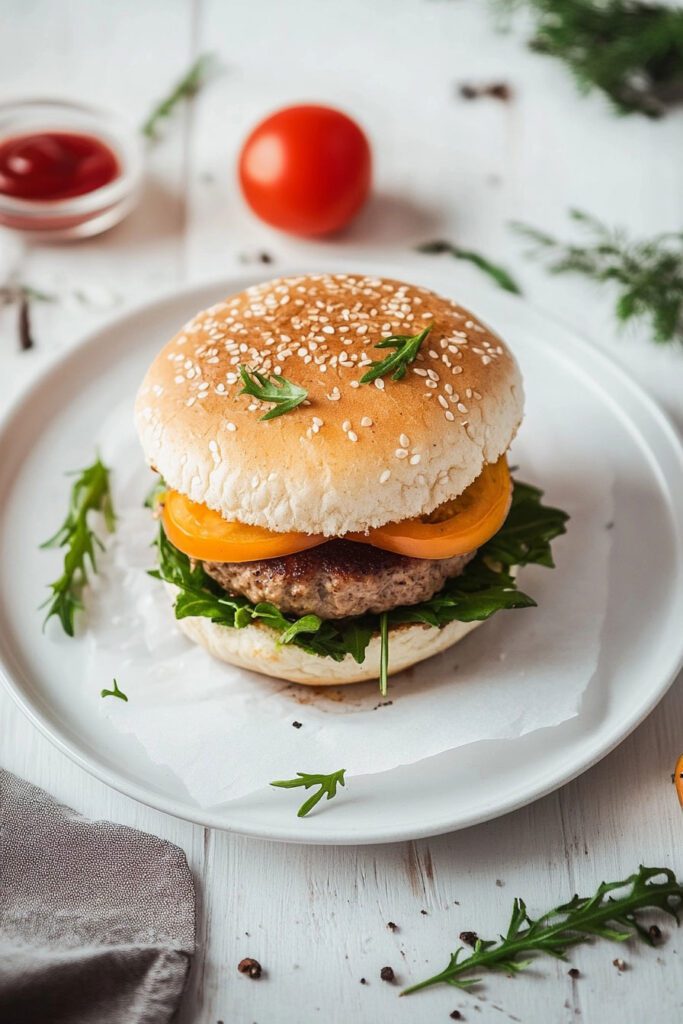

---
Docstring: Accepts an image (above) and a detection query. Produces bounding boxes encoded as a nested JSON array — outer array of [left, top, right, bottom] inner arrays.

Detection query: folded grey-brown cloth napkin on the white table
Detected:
[[0, 769, 195, 1024]]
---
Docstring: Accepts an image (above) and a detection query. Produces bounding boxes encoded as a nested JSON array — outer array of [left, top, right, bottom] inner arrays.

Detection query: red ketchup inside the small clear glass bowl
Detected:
[[0, 131, 121, 203]]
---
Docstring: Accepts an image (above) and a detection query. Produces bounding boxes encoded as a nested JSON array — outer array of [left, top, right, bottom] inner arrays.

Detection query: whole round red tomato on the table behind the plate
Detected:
[[240, 105, 371, 234]]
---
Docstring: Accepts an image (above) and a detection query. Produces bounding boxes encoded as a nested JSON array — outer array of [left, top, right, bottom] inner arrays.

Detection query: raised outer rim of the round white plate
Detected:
[[0, 266, 683, 846]]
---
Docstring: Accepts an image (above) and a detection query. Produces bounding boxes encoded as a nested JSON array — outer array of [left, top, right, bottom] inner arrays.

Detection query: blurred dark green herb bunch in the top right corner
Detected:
[[496, 0, 683, 118]]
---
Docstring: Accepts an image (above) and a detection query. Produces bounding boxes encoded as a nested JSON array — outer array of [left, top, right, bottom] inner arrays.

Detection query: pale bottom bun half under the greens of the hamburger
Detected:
[[169, 587, 481, 686]]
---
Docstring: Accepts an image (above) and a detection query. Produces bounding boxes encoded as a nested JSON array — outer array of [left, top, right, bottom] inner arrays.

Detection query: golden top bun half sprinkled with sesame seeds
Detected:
[[135, 274, 523, 537]]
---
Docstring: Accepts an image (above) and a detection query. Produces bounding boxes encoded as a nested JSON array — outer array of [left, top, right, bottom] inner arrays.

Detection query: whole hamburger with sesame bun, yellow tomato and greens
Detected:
[[135, 273, 567, 692]]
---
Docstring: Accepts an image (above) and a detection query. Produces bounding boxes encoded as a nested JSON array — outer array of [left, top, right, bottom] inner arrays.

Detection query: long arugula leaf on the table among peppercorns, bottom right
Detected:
[[400, 864, 683, 995]]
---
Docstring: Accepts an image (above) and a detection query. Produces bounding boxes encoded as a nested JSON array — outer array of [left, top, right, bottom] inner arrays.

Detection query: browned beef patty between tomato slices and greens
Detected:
[[204, 540, 475, 618]]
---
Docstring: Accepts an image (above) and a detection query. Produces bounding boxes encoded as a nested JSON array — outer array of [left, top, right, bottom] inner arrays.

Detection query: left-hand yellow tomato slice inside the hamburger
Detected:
[[162, 490, 327, 562]]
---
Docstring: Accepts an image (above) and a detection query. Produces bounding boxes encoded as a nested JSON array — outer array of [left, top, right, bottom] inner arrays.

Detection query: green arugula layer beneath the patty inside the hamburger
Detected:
[[151, 482, 568, 665]]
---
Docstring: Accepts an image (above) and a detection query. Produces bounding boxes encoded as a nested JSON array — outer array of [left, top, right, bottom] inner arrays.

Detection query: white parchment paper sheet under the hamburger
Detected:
[[85, 407, 612, 807]]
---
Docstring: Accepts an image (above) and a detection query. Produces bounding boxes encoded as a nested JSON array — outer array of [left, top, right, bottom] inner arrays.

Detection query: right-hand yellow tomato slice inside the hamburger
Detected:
[[347, 456, 512, 558]]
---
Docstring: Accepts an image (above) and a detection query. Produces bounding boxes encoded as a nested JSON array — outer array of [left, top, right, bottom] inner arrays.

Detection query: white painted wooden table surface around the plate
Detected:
[[0, 0, 683, 1024]]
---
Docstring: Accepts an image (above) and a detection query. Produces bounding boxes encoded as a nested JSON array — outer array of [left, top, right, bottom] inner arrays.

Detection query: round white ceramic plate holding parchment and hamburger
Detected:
[[0, 260, 683, 844]]
